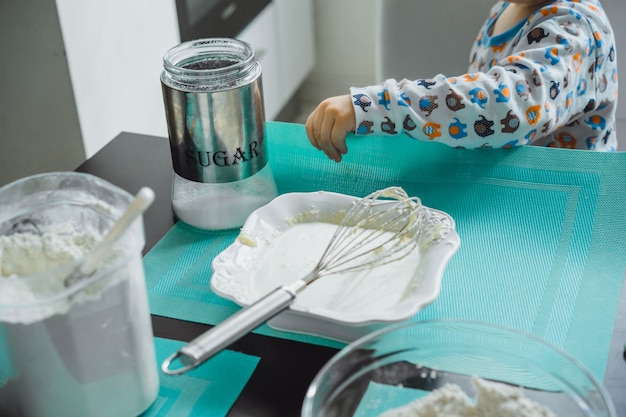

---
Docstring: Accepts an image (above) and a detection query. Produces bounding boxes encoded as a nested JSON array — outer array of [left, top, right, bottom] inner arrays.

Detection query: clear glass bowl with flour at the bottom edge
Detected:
[[302, 320, 616, 417]]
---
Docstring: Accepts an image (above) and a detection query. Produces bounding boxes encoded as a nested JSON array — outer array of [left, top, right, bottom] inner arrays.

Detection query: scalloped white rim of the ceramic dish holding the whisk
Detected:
[[210, 191, 460, 341]]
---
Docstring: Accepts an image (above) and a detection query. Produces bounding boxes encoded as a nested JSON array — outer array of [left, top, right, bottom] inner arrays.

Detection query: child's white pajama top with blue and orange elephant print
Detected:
[[350, 0, 617, 151]]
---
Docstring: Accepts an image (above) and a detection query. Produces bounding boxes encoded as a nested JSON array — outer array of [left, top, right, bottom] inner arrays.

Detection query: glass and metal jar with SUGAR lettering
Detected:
[[161, 38, 277, 230]]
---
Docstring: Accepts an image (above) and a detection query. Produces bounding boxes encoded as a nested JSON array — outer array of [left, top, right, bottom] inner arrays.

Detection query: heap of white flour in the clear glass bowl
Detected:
[[380, 377, 556, 417]]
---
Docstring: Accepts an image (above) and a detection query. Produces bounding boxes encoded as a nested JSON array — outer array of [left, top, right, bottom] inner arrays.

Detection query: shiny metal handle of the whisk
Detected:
[[161, 280, 306, 375]]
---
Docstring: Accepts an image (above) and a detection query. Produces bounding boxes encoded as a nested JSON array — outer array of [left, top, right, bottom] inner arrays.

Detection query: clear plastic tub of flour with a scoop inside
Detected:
[[0, 173, 159, 417]]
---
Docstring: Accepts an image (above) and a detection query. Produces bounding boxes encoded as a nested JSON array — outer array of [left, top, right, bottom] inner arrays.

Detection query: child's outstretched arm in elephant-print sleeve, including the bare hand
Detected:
[[307, 2, 616, 161]]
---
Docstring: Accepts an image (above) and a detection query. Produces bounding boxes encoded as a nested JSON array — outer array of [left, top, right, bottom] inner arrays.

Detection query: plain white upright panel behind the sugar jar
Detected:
[[56, 0, 180, 158]]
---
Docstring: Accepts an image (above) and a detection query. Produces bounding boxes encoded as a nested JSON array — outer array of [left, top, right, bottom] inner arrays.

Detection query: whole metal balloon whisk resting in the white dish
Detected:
[[161, 187, 422, 375]]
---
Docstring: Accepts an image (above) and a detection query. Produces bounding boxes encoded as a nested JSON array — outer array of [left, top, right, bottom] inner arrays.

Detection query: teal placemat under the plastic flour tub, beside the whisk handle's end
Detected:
[[141, 338, 259, 417]]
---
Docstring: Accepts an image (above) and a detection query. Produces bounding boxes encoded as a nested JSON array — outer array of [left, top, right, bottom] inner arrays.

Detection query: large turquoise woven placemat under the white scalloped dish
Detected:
[[145, 122, 626, 380]]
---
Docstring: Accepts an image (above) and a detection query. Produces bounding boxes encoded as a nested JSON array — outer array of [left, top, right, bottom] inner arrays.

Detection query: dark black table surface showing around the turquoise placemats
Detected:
[[77, 133, 626, 417]]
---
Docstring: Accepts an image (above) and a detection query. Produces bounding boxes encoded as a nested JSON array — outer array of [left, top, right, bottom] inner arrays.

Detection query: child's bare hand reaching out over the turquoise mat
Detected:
[[306, 94, 356, 162]]
